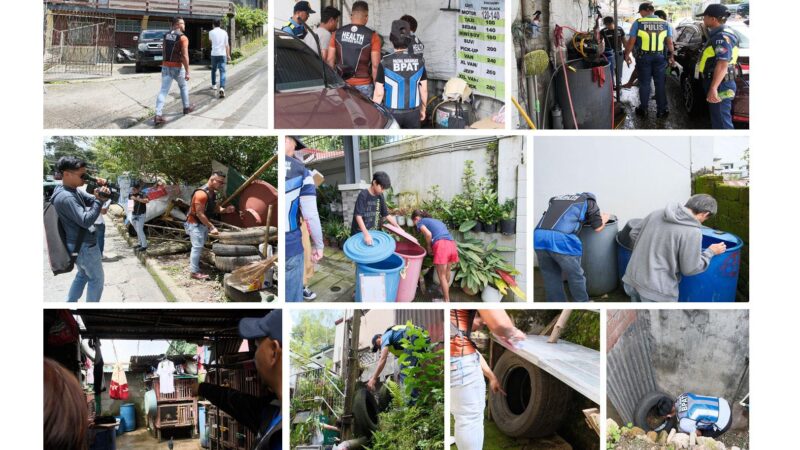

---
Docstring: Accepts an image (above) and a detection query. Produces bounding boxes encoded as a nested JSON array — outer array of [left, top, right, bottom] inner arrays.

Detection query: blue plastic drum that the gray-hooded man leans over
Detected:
[[617, 228, 744, 302]]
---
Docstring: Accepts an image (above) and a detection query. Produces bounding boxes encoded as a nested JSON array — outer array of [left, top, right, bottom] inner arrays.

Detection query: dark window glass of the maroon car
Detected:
[[275, 41, 344, 92]]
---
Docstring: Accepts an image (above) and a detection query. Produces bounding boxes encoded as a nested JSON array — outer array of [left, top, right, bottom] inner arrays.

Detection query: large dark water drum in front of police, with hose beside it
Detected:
[[556, 60, 614, 130]]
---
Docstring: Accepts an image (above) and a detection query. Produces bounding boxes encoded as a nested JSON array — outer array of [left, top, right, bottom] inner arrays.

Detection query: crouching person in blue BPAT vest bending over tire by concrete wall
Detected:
[[656, 392, 733, 438]]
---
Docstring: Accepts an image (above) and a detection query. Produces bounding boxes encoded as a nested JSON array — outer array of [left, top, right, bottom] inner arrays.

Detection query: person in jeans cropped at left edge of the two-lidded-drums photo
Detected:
[[284, 136, 325, 302]]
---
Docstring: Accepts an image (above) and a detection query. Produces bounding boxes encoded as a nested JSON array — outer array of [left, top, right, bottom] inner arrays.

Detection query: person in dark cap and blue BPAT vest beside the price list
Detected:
[[372, 20, 428, 128]]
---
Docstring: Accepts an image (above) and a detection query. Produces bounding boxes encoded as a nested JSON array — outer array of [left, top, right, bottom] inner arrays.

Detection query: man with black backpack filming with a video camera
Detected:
[[50, 156, 111, 302]]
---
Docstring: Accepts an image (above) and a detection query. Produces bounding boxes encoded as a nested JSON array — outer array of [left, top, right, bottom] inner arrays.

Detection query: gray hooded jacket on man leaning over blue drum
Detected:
[[622, 203, 714, 302]]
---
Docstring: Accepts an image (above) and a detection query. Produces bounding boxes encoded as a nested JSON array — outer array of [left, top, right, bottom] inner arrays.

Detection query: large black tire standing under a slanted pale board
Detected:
[[489, 351, 572, 437]]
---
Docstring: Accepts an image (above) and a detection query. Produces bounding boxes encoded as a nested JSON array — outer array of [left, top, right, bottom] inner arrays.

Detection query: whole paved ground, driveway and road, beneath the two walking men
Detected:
[[44, 47, 268, 129]]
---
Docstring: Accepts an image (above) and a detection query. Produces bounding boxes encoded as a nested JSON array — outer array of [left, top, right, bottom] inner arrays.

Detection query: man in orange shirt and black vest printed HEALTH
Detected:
[[327, 1, 381, 99]]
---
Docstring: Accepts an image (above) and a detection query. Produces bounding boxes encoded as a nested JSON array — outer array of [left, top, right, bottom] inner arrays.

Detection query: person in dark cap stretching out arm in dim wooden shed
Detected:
[[197, 309, 283, 450]]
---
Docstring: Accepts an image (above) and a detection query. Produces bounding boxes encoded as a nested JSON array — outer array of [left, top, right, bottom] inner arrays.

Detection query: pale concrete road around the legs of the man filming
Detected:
[[43, 218, 166, 303]]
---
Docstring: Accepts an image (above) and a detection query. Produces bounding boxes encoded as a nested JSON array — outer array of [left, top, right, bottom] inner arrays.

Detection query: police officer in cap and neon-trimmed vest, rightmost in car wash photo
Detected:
[[695, 4, 739, 129]]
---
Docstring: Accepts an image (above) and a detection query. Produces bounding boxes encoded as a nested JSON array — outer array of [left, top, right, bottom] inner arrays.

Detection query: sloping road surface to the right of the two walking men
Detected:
[[135, 48, 268, 129]]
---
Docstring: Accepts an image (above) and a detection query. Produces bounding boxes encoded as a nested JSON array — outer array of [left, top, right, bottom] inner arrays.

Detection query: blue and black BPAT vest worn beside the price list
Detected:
[[381, 52, 425, 109]]
